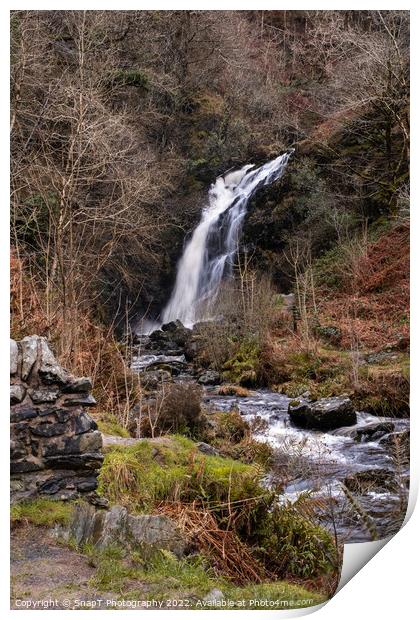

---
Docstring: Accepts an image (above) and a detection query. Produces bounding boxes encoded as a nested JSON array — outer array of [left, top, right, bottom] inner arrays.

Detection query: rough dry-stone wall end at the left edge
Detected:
[[10, 336, 103, 501]]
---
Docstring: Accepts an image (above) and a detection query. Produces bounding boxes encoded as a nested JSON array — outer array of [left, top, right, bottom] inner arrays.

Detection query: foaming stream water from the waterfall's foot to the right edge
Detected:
[[131, 340, 409, 543]]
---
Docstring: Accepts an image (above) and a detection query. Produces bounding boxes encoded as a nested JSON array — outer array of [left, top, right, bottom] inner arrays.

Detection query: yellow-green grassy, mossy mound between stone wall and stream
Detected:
[[99, 436, 267, 510]]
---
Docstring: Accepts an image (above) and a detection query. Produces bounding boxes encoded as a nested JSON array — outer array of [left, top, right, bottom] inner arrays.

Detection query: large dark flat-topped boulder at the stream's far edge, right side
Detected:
[[289, 396, 357, 431]]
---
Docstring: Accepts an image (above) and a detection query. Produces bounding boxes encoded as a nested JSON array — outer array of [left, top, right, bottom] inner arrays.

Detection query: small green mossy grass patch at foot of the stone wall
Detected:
[[10, 498, 74, 527]]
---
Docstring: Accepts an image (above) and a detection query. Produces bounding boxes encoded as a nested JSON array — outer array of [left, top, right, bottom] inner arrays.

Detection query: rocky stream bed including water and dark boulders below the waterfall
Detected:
[[131, 322, 409, 542]]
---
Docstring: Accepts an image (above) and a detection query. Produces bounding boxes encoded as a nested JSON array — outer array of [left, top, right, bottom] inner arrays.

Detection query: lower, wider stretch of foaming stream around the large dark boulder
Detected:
[[205, 389, 409, 542]]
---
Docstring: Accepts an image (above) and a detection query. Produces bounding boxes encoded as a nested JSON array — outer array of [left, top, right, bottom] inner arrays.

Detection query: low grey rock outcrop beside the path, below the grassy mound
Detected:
[[64, 502, 187, 558]]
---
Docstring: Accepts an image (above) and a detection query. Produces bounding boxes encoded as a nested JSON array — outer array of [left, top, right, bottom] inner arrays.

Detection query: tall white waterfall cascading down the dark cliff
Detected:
[[162, 149, 293, 327]]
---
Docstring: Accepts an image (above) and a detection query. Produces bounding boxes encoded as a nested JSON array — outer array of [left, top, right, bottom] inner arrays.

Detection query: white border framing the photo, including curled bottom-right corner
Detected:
[[0, 0, 420, 620]]
